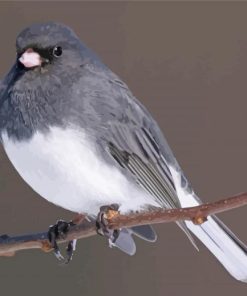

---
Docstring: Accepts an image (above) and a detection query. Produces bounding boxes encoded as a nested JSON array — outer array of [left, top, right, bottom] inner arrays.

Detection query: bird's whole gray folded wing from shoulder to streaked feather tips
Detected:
[[74, 64, 197, 247]]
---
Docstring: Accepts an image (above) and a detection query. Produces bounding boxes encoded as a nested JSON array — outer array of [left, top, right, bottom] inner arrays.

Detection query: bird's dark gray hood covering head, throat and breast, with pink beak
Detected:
[[0, 22, 102, 138]]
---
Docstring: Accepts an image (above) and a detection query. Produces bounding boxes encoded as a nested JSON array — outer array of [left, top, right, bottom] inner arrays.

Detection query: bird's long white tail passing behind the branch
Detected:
[[170, 168, 247, 282]]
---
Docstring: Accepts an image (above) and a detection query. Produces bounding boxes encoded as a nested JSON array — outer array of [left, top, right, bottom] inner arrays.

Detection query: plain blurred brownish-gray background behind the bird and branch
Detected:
[[0, 1, 247, 296]]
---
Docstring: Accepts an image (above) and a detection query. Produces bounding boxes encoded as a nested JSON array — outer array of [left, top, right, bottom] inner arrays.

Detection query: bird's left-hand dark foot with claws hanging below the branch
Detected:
[[48, 220, 76, 264]]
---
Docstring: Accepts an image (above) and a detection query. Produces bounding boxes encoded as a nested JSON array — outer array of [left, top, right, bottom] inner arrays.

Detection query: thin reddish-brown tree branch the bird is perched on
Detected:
[[0, 193, 247, 256]]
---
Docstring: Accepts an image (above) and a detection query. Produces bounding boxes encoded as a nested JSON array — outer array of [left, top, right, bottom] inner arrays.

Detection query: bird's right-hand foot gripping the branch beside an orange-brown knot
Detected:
[[96, 204, 119, 247]]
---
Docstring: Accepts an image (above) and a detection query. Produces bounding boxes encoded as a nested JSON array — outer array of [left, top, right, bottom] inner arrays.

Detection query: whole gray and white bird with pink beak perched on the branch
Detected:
[[0, 21, 247, 282]]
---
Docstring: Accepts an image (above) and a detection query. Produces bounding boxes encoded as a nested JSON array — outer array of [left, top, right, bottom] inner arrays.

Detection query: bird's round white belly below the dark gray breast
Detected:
[[2, 128, 157, 215]]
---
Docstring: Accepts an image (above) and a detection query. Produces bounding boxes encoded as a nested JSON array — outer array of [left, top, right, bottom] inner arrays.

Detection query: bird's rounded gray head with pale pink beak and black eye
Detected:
[[16, 22, 88, 76]]
